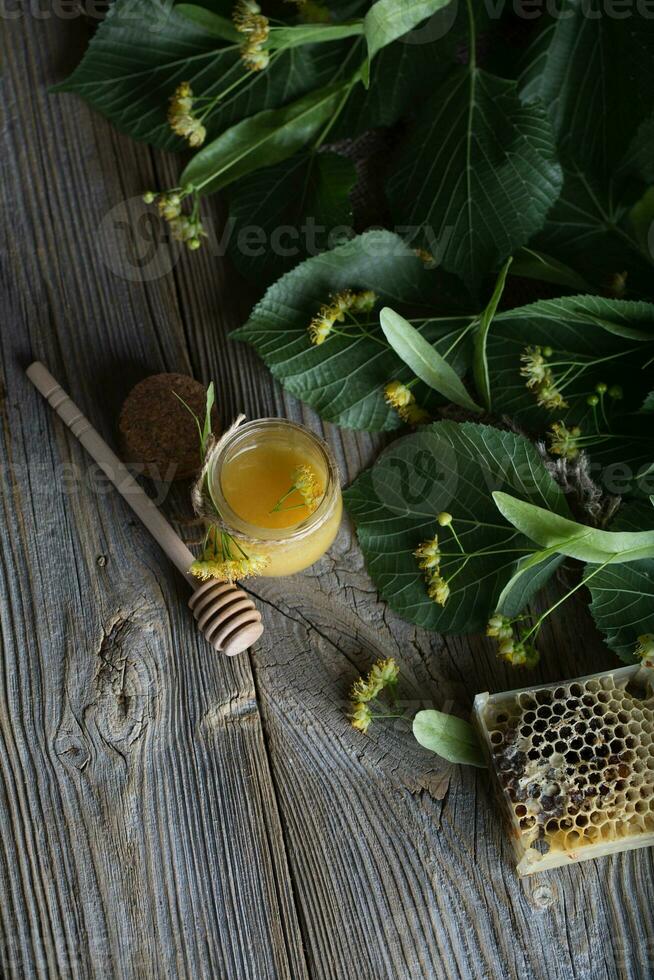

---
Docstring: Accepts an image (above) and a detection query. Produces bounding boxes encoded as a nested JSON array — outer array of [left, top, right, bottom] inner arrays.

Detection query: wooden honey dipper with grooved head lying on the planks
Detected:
[[27, 361, 263, 657]]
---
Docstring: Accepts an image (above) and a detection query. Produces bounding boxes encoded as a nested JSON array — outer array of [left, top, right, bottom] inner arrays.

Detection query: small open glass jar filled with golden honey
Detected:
[[207, 418, 343, 577]]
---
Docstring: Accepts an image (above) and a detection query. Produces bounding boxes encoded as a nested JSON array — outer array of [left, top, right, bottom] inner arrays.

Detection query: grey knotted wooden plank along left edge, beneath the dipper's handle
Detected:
[[0, 17, 305, 980]]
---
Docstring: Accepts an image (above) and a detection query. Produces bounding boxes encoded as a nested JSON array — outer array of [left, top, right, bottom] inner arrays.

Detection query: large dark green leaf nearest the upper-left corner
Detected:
[[54, 0, 350, 151]]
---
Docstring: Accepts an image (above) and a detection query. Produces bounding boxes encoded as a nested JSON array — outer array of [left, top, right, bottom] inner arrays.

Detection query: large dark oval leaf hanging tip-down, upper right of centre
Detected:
[[388, 66, 562, 289]]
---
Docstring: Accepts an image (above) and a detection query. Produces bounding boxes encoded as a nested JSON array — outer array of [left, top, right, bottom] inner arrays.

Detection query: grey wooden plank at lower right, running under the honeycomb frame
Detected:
[[246, 552, 654, 980]]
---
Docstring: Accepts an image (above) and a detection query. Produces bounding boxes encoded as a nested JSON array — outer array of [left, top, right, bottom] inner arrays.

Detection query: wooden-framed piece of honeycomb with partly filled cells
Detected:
[[474, 666, 654, 875]]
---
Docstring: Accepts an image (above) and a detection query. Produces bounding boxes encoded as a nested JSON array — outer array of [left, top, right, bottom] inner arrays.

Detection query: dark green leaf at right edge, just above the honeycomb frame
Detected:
[[588, 503, 654, 663]]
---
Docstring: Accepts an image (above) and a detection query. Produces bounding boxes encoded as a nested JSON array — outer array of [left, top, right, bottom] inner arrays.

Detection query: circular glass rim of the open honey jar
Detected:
[[207, 416, 340, 543]]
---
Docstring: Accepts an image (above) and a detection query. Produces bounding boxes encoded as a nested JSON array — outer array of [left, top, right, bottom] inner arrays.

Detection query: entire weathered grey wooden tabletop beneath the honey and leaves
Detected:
[[0, 4, 654, 980]]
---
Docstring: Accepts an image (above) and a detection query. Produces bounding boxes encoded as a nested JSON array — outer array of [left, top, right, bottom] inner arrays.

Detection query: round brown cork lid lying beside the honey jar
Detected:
[[119, 374, 220, 481]]
